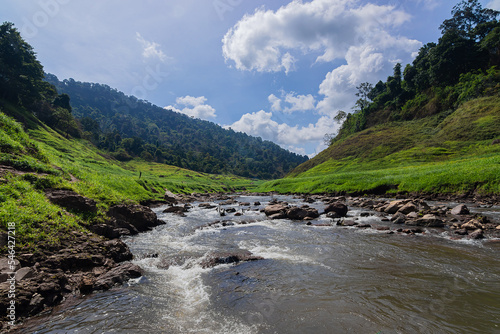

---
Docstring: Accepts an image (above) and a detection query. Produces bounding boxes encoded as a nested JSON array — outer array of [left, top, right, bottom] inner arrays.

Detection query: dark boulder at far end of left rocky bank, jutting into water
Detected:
[[107, 204, 165, 234]]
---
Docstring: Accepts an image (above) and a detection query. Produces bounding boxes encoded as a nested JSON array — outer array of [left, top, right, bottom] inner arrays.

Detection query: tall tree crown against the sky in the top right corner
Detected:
[[439, 0, 500, 41]]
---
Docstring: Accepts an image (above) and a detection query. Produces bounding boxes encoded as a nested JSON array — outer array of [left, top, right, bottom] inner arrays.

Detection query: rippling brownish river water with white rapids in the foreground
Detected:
[[15, 196, 500, 334]]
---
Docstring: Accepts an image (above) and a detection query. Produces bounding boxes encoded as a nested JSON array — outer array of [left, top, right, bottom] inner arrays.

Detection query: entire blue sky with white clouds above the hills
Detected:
[[0, 0, 500, 157]]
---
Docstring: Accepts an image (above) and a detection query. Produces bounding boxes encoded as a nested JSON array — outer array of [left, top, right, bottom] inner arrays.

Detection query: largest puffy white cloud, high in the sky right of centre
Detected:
[[222, 0, 422, 115]]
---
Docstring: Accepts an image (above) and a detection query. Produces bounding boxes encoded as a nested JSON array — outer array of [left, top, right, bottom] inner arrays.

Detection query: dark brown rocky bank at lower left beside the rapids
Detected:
[[0, 190, 163, 332]]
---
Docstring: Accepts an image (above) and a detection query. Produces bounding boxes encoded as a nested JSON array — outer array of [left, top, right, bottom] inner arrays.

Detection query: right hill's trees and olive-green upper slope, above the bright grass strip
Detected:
[[298, 0, 500, 175]]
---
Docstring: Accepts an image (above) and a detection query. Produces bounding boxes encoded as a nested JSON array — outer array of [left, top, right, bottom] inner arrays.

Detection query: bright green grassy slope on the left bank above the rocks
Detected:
[[0, 108, 255, 253]]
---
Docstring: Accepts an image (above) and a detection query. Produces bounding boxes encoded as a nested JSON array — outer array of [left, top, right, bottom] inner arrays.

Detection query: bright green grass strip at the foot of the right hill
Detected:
[[259, 154, 500, 194]]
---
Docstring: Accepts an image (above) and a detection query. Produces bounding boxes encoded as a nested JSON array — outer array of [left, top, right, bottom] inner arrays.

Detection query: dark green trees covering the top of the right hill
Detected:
[[325, 0, 500, 144]]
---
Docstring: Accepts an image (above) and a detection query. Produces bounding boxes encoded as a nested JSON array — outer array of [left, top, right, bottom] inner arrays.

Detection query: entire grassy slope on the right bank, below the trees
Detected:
[[259, 97, 500, 193]]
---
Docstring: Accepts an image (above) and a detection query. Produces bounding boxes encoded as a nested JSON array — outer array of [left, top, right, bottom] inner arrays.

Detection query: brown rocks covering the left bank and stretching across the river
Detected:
[[4, 190, 500, 331]]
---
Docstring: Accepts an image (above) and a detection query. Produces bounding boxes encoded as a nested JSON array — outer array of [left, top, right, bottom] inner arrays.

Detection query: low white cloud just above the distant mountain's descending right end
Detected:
[[225, 110, 339, 154]]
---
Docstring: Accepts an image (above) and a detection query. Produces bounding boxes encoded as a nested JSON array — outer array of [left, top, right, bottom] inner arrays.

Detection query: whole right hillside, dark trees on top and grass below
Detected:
[[259, 0, 500, 194]]
